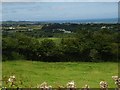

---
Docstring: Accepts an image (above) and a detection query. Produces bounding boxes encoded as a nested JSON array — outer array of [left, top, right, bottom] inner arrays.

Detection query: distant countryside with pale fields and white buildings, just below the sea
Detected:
[[2, 22, 120, 34]]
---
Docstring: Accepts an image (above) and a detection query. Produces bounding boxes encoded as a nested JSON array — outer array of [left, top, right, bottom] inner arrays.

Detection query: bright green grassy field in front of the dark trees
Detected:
[[2, 60, 118, 88]]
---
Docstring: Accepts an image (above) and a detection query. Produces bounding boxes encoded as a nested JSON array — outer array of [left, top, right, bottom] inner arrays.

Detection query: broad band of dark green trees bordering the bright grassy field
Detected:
[[2, 30, 120, 62]]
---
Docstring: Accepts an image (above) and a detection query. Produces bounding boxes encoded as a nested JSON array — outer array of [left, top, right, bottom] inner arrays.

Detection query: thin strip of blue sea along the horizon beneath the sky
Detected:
[[2, 18, 118, 24]]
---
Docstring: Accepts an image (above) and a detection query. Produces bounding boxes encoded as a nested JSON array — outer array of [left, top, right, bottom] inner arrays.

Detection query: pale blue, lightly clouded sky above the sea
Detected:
[[2, 0, 118, 21]]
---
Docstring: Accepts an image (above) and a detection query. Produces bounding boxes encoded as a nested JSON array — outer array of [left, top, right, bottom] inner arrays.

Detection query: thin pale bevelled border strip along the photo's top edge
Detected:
[[1, 0, 119, 2]]
